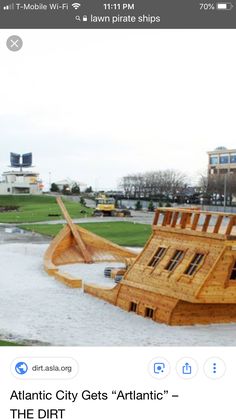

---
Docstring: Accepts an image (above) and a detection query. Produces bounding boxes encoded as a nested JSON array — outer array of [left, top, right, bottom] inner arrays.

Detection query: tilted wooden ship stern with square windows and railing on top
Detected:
[[84, 208, 236, 325]]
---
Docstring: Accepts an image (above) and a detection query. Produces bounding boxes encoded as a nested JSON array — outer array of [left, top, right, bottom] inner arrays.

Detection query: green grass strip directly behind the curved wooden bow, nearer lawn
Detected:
[[22, 221, 151, 247]]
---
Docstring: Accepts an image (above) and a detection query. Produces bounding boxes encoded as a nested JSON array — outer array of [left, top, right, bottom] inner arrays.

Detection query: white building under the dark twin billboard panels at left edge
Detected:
[[0, 170, 43, 195]]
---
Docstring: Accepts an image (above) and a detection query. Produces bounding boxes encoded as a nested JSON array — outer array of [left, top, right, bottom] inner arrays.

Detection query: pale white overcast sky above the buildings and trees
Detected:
[[0, 29, 236, 189]]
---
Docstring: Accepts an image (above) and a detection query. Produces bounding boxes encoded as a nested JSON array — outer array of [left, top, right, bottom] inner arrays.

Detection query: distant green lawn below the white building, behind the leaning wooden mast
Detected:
[[0, 195, 92, 223]]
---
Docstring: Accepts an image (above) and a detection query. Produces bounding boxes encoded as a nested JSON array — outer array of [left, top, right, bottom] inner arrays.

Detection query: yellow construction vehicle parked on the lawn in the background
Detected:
[[93, 195, 131, 217]]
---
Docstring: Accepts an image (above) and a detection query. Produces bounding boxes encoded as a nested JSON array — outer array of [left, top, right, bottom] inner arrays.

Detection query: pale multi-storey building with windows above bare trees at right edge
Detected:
[[208, 147, 236, 176]]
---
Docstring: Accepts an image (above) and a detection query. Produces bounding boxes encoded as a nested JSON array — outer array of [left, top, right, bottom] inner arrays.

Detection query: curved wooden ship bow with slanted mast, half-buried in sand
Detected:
[[44, 197, 137, 288]]
